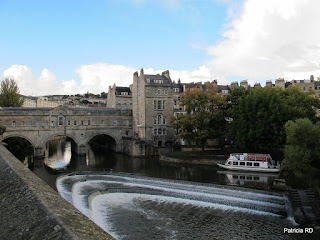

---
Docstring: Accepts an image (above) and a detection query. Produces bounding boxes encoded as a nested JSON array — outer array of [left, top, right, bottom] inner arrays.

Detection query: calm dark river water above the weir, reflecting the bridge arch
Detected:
[[33, 138, 276, 193]]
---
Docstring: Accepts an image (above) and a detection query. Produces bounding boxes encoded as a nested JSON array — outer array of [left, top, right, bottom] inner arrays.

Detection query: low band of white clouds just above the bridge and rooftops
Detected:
[[3, 63, 227, 96]]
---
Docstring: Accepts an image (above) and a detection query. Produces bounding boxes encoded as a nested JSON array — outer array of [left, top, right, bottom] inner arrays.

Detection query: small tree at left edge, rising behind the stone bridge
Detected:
[[0, 78, 24, 107]]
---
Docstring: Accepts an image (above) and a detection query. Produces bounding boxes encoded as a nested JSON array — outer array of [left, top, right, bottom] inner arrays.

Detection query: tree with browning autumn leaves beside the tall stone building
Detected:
[[174, 84, 226, 150]]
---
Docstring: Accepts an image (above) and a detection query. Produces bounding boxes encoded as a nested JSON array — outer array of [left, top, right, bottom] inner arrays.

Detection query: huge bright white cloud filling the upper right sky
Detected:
[[207, 0, 320, 79]]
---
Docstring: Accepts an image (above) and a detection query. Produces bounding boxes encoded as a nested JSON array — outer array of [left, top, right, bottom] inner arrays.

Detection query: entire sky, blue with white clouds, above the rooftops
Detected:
[[0, 0, 320, 96]]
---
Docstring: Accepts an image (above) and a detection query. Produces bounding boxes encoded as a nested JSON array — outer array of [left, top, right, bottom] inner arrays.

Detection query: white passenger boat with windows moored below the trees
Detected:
[[217, 153, 280, 173]]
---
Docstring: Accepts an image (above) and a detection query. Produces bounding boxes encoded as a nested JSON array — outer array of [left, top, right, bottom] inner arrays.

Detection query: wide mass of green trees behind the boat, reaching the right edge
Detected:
[[229, 86, 320, 152]]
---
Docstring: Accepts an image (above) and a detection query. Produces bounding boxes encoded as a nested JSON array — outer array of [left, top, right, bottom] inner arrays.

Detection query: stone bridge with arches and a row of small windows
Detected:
[[0, 106, 132, 156]]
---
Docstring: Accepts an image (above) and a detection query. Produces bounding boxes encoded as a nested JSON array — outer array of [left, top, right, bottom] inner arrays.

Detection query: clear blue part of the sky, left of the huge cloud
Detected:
[[0, 0, 227, 79]]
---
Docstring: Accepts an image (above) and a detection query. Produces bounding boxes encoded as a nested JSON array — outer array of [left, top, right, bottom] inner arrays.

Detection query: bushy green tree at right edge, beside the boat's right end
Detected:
[[281, 118, 320, 176]]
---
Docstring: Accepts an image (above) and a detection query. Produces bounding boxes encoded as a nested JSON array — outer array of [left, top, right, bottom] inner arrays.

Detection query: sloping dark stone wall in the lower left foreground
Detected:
[[0, 144, 114, 240]]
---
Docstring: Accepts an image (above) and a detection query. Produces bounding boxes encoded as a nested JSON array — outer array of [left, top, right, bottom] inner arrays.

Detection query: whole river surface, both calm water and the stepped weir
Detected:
[[28, 140, 310, 240]]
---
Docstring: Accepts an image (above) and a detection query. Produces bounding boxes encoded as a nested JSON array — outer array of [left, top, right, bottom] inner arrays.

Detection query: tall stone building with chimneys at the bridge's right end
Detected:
[[132, 69, 174, 147]]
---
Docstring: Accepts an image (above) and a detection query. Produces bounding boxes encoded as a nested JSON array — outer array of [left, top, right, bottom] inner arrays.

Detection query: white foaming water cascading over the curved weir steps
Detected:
[[56, 174, 290, 239]]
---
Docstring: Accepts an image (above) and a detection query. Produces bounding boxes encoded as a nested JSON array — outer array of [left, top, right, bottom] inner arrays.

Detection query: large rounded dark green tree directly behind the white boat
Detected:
[[229, 88, 289, 152]]
